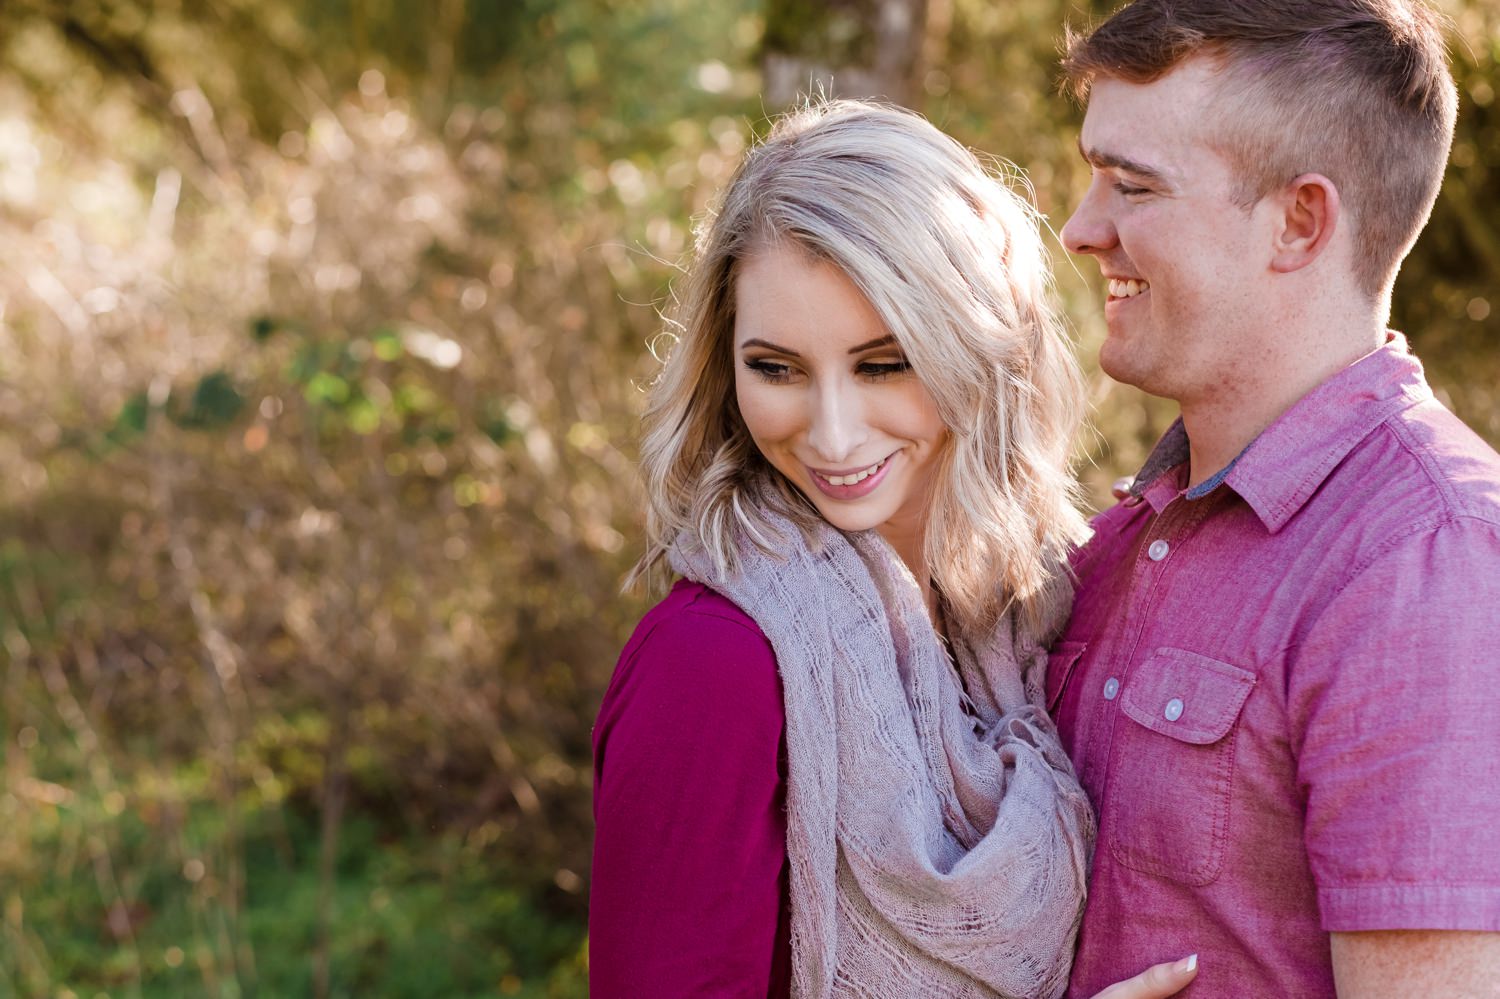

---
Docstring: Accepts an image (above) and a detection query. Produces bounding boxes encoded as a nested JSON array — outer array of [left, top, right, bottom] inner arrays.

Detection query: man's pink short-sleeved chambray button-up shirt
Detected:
[[1047, 335, 1500, 998]]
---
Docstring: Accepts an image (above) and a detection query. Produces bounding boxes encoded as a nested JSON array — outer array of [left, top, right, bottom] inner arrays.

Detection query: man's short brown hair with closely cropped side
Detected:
[[1062, 0, 1458, 297]]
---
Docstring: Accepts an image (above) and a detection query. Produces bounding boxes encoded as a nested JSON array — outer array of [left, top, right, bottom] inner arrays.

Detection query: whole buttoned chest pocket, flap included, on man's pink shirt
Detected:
[[1106, 648, 1256, 885]]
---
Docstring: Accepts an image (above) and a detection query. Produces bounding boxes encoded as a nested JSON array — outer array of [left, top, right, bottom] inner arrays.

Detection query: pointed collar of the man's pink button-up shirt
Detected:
[[1130, 332, 1433, 534]]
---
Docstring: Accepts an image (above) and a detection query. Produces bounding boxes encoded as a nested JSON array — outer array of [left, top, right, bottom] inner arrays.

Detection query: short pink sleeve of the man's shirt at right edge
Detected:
[[1286, 519, 1500, 932]]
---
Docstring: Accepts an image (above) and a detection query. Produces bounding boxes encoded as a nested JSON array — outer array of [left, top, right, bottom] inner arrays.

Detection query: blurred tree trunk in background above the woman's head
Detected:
[[762, 0, 929, 108]]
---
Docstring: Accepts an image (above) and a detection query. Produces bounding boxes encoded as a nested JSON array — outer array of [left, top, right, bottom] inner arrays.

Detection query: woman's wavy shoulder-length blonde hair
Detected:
[[630, 101, 1085, 629]]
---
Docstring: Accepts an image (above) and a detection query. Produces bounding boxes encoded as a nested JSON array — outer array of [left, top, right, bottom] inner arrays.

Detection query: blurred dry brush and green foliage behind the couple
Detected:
[[0, 0, 1500, 999]]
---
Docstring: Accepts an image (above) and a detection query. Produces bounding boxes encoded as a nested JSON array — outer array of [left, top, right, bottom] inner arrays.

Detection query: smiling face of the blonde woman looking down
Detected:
[[734, 245, 948, 570]]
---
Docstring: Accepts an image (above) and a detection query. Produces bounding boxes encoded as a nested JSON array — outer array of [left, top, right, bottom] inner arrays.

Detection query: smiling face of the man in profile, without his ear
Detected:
[[1062, 59, 1274, 405]]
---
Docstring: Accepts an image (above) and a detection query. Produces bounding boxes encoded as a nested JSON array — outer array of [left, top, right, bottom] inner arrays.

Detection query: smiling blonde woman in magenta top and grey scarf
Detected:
[[590, 102, 1191, 999]]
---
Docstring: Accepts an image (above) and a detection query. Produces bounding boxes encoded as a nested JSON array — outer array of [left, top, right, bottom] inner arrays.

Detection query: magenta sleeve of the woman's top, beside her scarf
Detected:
[[590, 584, 789, 999]]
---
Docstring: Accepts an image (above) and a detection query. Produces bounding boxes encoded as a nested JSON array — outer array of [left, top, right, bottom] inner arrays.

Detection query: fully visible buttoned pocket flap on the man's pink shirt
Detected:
[[1128, 648, 1256, 746]]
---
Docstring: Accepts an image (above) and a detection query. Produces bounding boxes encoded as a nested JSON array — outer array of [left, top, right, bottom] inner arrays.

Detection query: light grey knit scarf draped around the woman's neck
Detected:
[[671, 516, 1094, 999]]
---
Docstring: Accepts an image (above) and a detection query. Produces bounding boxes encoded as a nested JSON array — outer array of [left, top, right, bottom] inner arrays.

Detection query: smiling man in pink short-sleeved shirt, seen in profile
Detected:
[[1047, 0, 1500, 998]]
